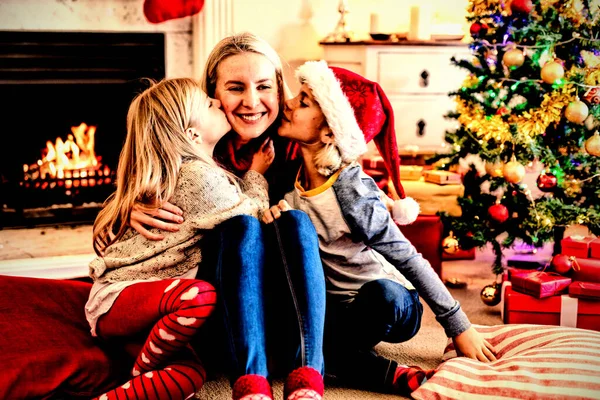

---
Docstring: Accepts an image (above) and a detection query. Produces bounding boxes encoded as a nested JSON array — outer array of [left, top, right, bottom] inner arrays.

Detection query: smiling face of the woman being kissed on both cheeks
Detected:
[[215, 52, 279, 143]]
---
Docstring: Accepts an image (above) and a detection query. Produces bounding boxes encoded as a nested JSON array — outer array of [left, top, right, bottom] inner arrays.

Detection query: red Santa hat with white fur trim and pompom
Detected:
[[296, 61, 419, 225]]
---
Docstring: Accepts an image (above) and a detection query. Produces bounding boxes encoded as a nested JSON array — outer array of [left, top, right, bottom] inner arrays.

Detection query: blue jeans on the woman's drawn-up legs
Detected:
[[207, 210, 325, 382]]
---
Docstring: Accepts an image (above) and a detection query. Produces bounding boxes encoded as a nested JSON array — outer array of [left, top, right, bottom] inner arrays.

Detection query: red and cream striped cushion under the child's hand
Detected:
[[412, 325, 600, 399]]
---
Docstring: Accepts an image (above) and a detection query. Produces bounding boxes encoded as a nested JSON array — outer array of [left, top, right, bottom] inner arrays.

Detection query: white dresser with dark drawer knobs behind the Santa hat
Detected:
[[321, 41, 471, 154]]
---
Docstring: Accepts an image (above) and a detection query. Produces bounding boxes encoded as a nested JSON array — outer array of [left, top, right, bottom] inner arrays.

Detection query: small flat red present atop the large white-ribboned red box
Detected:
[[510, 271, 572, 299]]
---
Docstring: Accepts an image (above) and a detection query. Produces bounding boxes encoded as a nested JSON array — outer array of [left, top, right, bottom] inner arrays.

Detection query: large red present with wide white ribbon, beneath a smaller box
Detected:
[[503, 288, 600, 331]]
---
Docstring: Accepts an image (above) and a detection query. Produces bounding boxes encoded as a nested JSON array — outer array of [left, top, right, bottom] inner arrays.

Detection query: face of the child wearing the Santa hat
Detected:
[[279, 84, 326, 144]]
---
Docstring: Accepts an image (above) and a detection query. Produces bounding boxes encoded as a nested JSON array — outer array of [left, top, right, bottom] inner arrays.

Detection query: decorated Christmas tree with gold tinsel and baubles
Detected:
[[430, 0, 600, 274]]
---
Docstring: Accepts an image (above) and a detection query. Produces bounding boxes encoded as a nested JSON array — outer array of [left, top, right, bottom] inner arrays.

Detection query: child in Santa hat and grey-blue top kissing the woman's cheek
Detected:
[[263, 61, 495, 395]]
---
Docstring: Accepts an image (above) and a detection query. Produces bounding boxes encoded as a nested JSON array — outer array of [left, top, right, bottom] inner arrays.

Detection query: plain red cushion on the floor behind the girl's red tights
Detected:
[[0, 276, 133, 399]]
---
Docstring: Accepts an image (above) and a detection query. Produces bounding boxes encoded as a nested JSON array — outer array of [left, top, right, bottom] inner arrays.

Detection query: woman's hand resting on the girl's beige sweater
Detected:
[[129, 202, 183, 240]]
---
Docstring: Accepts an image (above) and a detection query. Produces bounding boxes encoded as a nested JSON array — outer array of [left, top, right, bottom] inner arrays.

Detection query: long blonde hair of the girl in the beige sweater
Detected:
[[93, 78, 216, 255]]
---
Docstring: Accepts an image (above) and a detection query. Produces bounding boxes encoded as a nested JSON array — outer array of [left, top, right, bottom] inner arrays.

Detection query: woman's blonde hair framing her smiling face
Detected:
[[202, 32, 292, 138]]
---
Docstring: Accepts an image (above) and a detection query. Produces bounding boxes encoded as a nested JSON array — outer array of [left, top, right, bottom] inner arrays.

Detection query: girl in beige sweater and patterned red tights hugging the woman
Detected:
[[85, 78, 274, 399]]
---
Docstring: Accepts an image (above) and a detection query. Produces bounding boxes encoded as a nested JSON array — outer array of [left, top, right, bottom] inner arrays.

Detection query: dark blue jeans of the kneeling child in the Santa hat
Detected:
[[325, 279, 423, 391]]
